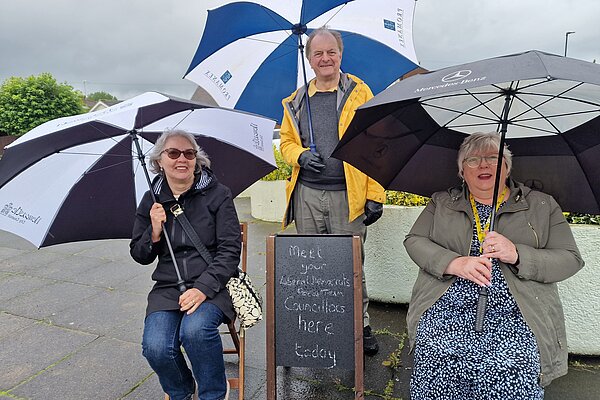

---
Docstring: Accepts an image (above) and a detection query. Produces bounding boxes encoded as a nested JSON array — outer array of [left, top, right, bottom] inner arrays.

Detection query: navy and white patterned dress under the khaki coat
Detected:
[[410, 203, 544, 400]]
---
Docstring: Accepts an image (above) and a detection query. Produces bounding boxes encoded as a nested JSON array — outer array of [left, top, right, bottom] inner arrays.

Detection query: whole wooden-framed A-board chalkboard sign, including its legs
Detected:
[[267, 235, 363, 399]]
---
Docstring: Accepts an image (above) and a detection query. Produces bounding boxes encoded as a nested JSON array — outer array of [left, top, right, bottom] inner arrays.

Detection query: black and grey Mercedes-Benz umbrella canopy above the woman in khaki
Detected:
[[333, 51, 600, 214]]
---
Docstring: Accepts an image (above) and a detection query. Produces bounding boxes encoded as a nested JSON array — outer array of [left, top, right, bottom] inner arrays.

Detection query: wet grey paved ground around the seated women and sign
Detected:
[[0, 199, 600, 400]]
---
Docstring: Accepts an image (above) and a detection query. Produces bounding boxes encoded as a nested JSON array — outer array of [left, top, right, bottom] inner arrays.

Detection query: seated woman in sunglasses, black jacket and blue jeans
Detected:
[[130, 130, 241, 400]]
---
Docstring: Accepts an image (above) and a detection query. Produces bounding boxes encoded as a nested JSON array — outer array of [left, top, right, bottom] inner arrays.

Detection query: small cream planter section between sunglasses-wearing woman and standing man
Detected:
[[250, 181, 287, 222]]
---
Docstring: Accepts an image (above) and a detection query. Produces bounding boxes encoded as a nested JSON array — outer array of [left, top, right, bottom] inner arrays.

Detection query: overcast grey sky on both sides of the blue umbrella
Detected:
[[0, 0, 600, 99]]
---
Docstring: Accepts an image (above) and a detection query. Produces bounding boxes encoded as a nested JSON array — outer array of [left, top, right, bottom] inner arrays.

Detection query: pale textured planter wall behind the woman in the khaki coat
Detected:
[[365, 205, 600, 355]]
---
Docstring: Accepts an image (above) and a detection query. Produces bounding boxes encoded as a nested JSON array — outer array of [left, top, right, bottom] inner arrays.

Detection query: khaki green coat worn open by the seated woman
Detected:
[[404, 180, 584, 386]]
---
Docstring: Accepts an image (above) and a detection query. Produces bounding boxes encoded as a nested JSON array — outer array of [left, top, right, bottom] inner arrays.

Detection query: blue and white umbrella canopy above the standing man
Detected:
[[185, 0, 417, 121]]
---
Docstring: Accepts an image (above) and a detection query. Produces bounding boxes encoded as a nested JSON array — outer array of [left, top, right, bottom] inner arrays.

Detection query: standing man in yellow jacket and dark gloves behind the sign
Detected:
[[280, 28, 385, 355]]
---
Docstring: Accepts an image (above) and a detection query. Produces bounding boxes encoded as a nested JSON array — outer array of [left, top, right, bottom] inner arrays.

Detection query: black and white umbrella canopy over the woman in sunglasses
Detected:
[[0, 92, 275, 247]]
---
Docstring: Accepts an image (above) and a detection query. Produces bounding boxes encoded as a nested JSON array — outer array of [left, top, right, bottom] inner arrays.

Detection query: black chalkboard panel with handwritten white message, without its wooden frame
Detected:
[[274, 236, 354, 369]]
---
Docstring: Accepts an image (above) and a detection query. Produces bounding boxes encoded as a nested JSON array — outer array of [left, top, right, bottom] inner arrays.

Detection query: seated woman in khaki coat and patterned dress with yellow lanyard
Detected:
[[404, 132, 583, 400]]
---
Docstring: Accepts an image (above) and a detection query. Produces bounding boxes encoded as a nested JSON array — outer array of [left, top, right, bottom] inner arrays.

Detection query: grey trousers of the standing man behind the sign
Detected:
[[294, 182, 369, 326]]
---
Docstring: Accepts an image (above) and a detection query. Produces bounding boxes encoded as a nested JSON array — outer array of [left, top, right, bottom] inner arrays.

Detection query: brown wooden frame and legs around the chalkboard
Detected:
[[266, 234, 364, 400]]
